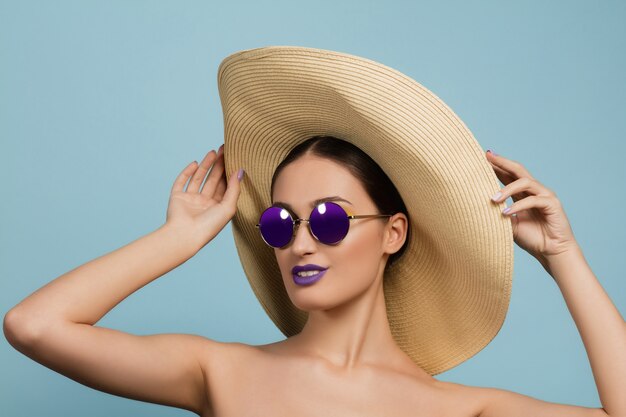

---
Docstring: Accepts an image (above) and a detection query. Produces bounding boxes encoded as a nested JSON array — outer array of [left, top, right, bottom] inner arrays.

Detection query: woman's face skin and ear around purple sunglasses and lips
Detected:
[[272, 155, 388, 311]]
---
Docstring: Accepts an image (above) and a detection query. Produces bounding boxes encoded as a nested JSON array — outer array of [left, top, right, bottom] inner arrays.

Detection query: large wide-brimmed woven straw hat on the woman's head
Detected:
[[218, 46, 513, 375]]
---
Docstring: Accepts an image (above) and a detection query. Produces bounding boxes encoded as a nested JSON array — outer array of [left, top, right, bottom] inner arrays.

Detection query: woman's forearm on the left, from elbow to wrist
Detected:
[[5, 223, 197, 339]]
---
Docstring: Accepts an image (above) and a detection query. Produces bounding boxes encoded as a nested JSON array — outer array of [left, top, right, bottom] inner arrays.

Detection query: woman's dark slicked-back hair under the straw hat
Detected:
[[270, 136, 410, 268]]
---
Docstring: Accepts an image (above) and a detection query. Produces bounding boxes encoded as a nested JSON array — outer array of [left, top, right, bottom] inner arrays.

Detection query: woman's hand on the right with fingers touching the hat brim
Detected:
[[487, 152, 578, 265]]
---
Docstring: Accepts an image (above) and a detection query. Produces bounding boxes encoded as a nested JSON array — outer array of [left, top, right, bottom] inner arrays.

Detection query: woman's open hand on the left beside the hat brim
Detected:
[[166, 145, 240, 250]]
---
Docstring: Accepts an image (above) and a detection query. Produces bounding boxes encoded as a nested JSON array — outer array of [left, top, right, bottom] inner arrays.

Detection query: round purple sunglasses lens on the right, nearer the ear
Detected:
[[310, 202, 350, 245]]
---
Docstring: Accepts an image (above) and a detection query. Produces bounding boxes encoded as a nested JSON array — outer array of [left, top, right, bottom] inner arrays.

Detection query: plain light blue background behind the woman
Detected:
[[0, 0, 626, 417]]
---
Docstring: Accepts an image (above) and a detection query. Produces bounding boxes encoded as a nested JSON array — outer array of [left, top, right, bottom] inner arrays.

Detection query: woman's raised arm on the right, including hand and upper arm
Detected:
[[474, 152, 626, 417]]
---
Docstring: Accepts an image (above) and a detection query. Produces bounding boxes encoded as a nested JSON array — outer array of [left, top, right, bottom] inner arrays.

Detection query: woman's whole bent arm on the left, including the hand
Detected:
[[4, 145, 239, 414]]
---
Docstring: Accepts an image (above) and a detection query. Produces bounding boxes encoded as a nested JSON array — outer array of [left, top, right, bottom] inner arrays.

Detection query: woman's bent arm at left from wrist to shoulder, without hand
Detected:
[[4, 221, 211, 414]]
